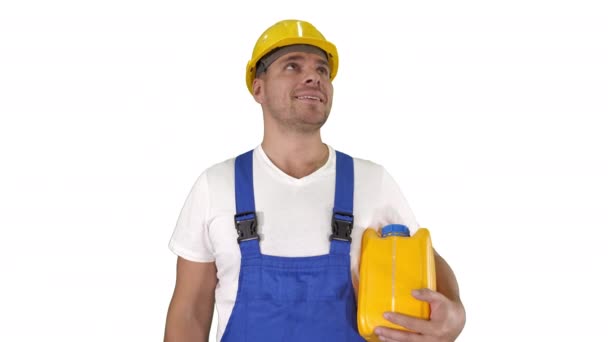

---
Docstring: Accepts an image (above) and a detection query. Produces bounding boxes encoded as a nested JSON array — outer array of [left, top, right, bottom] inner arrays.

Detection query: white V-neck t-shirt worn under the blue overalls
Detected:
[[169, 145, 418, 341]]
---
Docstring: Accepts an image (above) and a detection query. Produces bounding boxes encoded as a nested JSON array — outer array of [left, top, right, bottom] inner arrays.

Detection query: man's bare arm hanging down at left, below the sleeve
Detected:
[[165, 257, 217, 342]]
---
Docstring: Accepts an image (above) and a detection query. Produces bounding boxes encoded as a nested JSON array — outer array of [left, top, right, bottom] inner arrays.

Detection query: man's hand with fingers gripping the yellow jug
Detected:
[[374, 289, 465, 342]]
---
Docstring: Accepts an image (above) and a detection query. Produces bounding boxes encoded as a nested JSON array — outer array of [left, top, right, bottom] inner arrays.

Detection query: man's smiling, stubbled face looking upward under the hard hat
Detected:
[[253, 52, 333, 132]]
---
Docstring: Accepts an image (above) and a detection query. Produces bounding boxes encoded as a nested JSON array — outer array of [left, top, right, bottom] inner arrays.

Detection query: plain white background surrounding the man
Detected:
[[0, 0, 608, 341]]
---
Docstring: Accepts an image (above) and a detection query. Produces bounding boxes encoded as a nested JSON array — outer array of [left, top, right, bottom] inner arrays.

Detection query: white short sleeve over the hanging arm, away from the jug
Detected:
[[169, 172, 215, 262]]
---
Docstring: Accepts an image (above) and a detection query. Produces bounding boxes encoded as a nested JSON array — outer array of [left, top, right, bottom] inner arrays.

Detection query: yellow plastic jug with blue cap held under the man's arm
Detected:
[[357, 224, 436, 341]]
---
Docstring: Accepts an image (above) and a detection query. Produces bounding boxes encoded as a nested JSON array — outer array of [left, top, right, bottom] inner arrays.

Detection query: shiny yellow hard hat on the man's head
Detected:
[[245, 19, 338, 94]]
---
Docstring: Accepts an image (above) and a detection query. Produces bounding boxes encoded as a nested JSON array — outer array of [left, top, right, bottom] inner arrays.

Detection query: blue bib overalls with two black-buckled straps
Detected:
[[222, 151, 364, 342]]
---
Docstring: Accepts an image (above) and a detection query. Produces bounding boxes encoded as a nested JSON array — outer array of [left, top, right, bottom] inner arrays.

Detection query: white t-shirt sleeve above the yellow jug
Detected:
[[381, 167, 419, 235]]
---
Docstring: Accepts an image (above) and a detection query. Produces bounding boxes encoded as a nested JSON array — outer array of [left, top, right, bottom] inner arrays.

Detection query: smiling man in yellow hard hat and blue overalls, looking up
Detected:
[[165, 20, 465, 342]]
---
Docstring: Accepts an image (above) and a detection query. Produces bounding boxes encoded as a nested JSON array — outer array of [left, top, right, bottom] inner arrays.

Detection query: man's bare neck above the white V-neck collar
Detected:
[[262, 135, 329, 179]]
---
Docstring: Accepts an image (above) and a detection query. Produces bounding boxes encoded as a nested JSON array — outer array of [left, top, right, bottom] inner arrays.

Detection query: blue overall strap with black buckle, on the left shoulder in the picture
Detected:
[[234, 150, 260, 257]]
